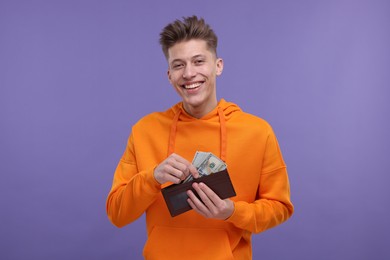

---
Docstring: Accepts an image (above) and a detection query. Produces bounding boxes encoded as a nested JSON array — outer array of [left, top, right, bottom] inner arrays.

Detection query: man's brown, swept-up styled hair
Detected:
[[160, 15, 218, 59]]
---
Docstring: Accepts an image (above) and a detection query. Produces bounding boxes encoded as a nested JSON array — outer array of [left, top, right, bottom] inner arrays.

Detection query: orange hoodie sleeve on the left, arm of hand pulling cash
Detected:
[[106, 135, 161, 227]]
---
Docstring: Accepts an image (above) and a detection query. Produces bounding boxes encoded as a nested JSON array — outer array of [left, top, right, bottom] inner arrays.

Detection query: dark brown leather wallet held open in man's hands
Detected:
[[161, 169, 236, 217]]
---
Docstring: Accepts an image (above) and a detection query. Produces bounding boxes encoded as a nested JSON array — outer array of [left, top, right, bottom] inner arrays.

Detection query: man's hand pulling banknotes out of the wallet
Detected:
[[154, 153, 199, 184]]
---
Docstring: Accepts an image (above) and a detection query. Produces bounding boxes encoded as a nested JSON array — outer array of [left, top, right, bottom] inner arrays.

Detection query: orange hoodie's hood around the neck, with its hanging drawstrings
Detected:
[[168, 99, 241, 161]]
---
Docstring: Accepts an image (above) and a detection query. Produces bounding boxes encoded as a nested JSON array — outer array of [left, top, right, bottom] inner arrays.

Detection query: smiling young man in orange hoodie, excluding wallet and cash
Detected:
[[107, 16, 293, 260]]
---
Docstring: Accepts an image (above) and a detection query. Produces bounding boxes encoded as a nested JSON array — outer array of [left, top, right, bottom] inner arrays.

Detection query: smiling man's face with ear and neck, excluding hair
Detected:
[[168, 39, 223, 118]]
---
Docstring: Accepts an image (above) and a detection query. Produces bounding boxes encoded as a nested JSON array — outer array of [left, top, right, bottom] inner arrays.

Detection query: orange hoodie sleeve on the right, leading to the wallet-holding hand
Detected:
[[227, 131, 294, 233]]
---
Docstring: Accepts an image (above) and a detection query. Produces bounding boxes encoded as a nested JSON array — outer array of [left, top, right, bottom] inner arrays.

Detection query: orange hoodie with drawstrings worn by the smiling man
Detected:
[[107, 99, 293, 260]]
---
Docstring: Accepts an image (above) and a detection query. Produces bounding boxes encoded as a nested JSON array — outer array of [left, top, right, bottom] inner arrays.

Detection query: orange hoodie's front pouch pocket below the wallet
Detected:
[[143, 226, 234, 260]]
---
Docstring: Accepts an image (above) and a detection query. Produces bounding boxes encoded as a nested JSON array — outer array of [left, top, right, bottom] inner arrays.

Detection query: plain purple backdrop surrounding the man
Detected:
[[0, 0, 390, 260]]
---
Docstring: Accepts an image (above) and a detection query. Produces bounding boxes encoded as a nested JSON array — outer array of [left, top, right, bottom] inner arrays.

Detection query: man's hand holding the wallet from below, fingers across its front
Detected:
[[187, 182, 234, 220]]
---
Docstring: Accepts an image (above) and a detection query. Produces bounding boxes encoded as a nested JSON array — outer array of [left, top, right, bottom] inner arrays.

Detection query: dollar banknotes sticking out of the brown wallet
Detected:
[[183, 151, 226, 183]]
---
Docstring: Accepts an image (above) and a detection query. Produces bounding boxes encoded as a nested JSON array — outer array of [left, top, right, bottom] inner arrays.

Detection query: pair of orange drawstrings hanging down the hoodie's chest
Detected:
[[168, 107, 227, 162]]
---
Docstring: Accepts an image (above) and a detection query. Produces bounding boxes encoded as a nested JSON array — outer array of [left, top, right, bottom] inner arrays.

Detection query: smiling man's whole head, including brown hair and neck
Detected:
[[160, 16, 223, 118]]
